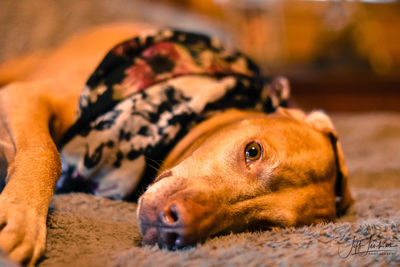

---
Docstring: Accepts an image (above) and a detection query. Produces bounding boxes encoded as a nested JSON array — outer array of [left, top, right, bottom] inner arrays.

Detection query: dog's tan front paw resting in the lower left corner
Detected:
[[0, 195, 46, 266]]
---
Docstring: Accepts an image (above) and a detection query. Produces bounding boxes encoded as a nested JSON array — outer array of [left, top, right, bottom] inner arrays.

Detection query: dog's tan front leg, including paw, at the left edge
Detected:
[[0, 83, 61, 265]]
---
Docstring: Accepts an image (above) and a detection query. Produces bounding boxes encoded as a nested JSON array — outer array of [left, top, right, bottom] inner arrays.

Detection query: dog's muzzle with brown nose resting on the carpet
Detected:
[[137, 177, 215, 249]]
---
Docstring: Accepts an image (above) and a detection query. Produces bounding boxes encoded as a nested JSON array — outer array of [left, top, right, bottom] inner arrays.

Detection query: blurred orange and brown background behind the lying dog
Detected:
[[0, 0, 400, 111]]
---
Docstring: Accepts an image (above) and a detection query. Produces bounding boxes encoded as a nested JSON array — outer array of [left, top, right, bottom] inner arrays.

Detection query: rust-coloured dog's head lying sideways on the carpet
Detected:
[[137, 109, 352, 247]]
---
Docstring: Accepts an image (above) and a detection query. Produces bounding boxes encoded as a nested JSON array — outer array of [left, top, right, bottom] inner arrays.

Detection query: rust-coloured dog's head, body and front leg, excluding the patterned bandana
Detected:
[[0, 25, 351, 263]]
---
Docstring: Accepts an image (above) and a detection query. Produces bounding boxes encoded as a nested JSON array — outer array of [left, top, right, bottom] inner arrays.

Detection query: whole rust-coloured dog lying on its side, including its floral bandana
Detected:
[[0, 24, 353, 265]]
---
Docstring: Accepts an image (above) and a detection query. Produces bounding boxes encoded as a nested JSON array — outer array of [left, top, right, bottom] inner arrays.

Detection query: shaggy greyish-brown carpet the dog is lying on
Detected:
[[0, 113, 400, 267]]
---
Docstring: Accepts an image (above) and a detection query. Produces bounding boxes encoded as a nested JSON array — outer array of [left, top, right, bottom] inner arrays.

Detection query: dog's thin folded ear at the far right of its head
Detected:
[[305, 111, 353, 215]]
